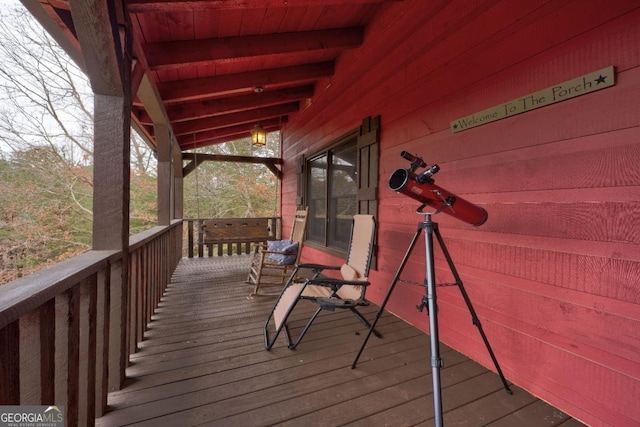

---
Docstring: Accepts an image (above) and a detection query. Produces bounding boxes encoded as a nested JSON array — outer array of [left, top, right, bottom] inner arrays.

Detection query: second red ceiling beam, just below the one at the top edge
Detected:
[[143, 27, 364, 70]]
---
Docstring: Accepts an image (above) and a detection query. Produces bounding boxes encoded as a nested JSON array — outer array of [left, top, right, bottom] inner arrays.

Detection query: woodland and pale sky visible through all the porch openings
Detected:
[[0, 5, 280, 284]]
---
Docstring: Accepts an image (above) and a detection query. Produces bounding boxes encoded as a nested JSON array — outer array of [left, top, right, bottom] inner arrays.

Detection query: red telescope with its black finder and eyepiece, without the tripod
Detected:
[[389, 151, 489, 227]]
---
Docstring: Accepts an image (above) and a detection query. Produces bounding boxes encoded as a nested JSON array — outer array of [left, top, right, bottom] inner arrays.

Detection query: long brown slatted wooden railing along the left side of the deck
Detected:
[[0, 221, 182, 426]]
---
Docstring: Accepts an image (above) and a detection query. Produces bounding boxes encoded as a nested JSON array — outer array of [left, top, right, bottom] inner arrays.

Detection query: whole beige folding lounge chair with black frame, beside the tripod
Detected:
[[264, 215, 380, 350]]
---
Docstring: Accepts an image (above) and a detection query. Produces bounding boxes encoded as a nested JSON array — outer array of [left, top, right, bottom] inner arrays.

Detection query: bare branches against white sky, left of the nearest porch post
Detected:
[[0, 8, 93, 166]]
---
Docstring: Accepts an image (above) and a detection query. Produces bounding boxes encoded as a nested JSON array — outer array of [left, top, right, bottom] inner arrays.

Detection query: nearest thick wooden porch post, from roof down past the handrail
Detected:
[[69, 0, 133, 389]]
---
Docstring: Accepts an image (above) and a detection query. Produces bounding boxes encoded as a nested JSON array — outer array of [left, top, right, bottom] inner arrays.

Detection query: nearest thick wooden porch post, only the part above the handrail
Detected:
[[69, 0, 131, 250]]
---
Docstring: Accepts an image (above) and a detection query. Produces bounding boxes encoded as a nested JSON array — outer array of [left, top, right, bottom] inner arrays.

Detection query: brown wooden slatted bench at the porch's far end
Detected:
[[201, 218, 277, 256]]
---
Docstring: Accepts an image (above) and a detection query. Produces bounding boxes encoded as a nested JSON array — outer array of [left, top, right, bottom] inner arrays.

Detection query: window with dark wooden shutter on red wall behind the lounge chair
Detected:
[[298, 118, 379, 254]]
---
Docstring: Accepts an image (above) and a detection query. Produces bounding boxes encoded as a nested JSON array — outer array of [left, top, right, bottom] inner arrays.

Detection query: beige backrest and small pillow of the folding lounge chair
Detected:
[[338, 215, 376, 300]]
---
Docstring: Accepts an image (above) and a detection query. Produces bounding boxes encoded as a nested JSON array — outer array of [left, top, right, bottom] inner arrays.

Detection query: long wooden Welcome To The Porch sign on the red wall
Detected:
[[450, 65, 615, 133]]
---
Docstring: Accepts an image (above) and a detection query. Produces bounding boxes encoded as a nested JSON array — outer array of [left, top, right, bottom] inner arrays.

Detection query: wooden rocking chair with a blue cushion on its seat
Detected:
[[246, 208, 309, 297]]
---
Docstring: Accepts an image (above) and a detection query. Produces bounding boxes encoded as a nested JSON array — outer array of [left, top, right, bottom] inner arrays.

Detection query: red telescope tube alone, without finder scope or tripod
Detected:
[[389, 168, 489, 227]]
